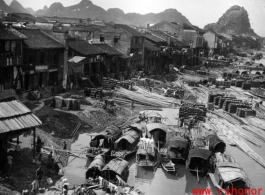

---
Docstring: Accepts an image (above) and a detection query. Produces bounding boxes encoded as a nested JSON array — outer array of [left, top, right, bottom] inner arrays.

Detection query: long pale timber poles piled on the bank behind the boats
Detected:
[[115, 87, 178, 108]]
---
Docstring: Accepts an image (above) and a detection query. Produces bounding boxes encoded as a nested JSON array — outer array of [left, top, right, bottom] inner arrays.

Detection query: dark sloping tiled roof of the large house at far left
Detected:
[[17, 28, 64, 49]]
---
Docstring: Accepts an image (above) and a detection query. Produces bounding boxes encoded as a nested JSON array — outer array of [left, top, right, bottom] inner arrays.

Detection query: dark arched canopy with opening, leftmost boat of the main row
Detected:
[[90, 125, 122, 148]]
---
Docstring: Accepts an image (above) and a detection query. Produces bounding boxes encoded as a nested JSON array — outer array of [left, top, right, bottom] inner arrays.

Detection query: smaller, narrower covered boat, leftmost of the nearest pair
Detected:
[[86, 155, 105, 179]]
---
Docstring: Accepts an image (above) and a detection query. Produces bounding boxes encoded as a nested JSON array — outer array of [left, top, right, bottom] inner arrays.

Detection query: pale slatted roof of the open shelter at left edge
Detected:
[[0, 100, 42, 133]]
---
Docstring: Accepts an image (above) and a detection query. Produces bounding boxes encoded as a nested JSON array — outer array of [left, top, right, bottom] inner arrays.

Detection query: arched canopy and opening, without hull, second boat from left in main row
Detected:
[[114, 130, 140, 151]]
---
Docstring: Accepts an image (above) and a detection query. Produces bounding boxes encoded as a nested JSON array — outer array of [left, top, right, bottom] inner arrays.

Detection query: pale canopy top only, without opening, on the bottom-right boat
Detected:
[[217, 163, 248, 182]]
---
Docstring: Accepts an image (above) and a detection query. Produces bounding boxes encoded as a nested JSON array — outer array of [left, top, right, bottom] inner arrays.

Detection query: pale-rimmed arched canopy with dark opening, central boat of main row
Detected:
[[146, 123, 168, 147]]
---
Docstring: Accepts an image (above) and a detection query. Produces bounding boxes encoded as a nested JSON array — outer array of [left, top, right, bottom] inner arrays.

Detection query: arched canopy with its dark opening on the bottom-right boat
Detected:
[[215, 162, 250, 189]]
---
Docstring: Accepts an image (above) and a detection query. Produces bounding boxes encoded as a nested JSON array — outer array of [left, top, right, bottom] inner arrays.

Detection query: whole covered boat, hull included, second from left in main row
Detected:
[[111, 129, 141, 157]]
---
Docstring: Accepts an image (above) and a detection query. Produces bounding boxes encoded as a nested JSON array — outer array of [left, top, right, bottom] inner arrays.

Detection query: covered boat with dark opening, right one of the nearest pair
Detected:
[[101, 158, 129, 181]]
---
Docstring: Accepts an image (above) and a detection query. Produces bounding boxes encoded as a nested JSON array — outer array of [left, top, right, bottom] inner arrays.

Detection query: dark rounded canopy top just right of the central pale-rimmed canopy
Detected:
[[165, 132, 188, 150]]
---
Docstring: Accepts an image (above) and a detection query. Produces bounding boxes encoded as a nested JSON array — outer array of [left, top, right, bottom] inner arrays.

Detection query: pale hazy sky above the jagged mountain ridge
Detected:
[[5, 0, 265, 37]]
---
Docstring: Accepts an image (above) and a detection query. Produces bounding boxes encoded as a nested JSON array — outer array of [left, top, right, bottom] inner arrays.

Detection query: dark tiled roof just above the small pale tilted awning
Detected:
[[69, 40, 106, 55]]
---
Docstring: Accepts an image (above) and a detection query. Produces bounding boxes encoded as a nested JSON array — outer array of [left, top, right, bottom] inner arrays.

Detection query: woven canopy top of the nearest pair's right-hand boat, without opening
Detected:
[[102, 158, 129, 175]]
